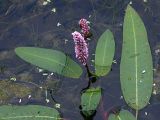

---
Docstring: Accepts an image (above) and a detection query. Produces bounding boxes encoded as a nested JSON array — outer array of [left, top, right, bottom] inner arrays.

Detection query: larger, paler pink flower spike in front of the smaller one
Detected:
[[72, 31, 88, 65]]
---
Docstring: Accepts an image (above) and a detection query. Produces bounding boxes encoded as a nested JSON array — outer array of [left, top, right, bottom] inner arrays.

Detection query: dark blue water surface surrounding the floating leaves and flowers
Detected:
[[0, 0, 160, 120]]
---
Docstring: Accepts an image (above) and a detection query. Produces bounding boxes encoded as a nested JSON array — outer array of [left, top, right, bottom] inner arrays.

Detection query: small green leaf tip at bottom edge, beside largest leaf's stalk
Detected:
[[108, 110, 136, 120]]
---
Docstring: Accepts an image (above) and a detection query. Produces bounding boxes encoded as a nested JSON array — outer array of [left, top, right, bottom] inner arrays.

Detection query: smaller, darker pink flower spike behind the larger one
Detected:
[[79, 19, 90, 39]]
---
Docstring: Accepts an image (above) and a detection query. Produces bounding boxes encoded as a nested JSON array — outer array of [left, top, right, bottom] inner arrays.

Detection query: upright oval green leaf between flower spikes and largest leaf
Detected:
[[95, 30, 115, 76]]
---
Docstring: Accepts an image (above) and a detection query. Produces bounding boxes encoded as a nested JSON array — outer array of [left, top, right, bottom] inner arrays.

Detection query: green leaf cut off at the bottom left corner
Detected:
[[0, 105, 62, 120]]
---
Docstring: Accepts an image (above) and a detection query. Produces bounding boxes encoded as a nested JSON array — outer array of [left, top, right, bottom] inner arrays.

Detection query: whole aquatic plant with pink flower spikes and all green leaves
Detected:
[[0, 5, 153, 120]]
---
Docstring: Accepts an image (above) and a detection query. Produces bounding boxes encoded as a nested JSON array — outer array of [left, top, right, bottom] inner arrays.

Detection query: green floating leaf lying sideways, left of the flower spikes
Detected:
[[15, 47, 82, 78]]
